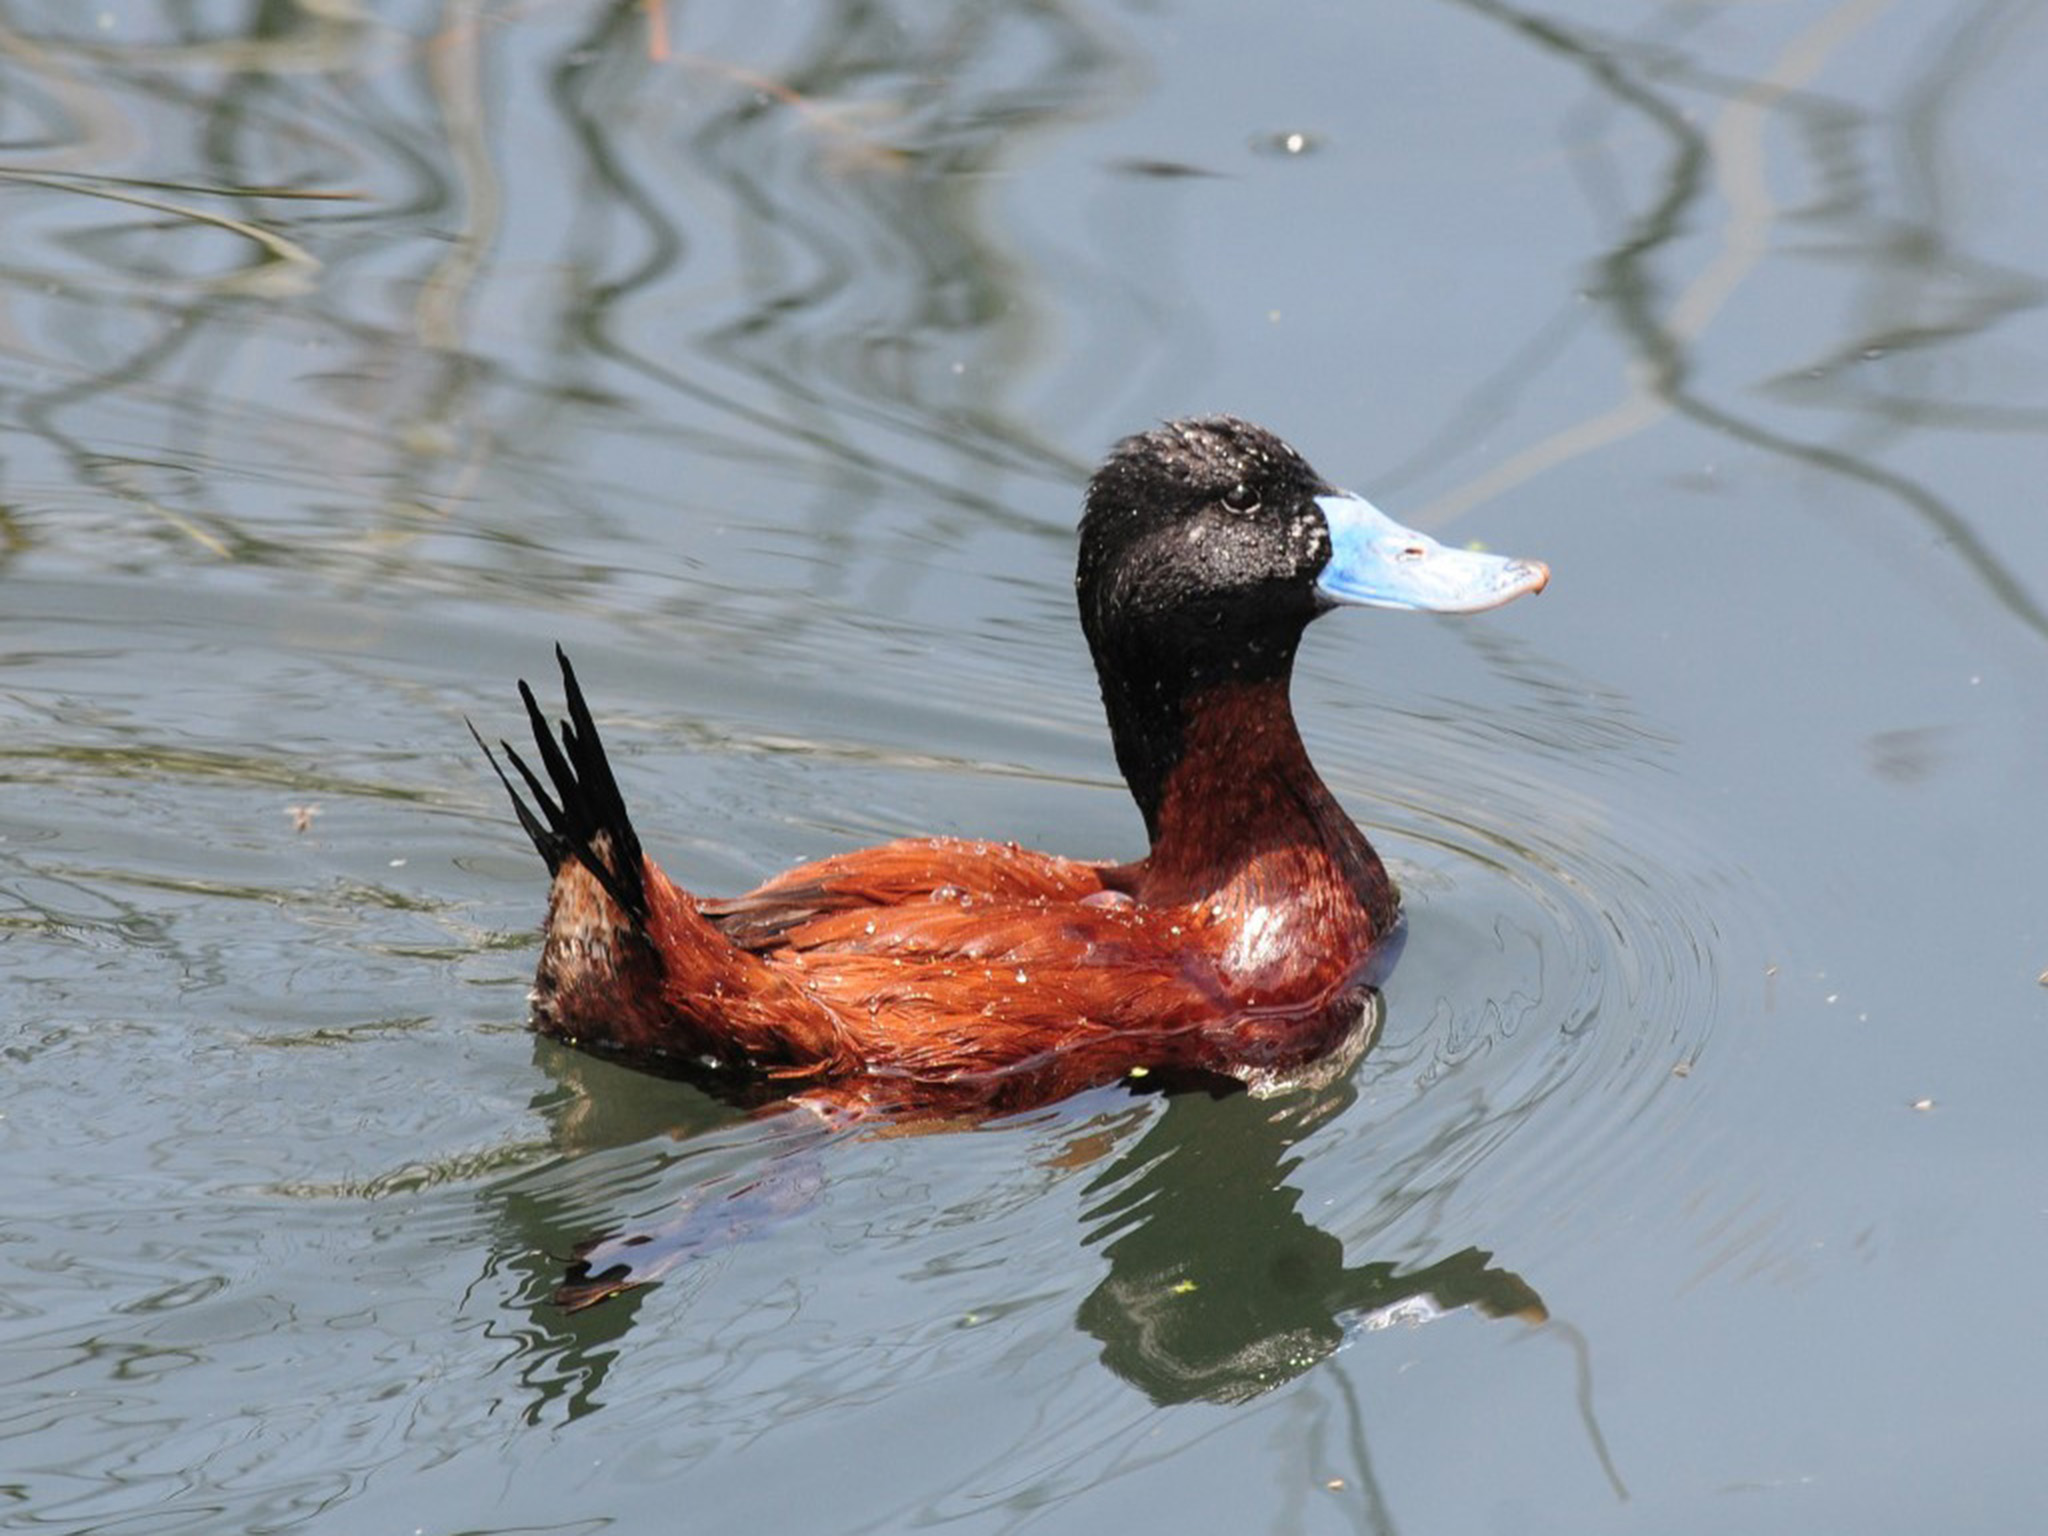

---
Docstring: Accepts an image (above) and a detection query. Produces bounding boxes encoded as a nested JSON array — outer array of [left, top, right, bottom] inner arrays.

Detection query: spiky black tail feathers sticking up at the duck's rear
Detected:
[[469, 645, 647, 922]]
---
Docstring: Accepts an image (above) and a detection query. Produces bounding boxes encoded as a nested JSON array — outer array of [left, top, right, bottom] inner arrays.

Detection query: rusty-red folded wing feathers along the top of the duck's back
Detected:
[[698, 838, 1110, 952]]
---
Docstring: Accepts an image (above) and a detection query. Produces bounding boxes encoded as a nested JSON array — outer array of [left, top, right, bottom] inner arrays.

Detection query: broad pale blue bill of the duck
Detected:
[[1315, 494, 1550, 612]]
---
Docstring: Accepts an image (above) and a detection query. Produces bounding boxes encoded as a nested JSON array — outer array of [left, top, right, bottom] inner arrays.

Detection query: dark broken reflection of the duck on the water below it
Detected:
[[494, 1011, 1546, 1415]]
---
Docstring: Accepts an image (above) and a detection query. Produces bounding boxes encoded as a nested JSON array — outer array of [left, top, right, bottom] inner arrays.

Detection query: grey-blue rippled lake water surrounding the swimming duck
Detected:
[[0, 0, 2048, 1536]]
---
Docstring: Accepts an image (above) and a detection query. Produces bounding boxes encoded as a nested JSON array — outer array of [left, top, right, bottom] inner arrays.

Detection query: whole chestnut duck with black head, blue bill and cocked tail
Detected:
[[471, 416, 1550, 1116]]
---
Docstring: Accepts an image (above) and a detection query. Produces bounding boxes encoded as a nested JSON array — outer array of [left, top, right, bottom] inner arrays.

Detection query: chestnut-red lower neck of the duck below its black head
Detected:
[[1112, 674, 1399, 938]]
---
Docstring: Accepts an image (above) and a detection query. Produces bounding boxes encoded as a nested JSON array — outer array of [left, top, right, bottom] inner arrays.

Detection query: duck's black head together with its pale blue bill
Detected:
[[1075, 416, 1548, 825]]
